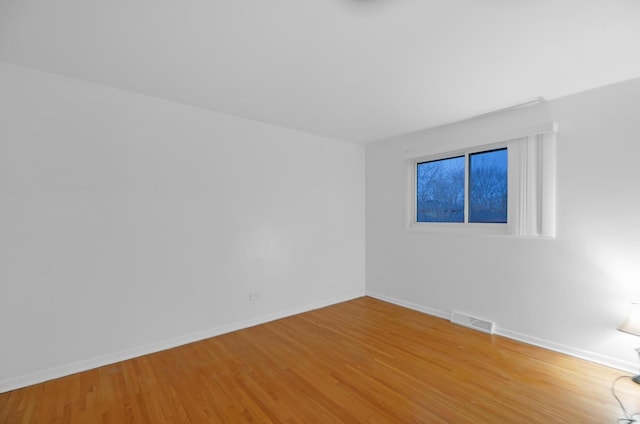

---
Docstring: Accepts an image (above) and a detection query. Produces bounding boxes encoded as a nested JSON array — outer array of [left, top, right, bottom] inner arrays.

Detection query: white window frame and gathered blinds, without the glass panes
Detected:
[[405, 123, 557, 238]]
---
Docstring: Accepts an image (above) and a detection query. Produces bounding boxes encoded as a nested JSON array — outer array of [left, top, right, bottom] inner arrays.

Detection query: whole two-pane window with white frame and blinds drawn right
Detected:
[[406, 124, 556, 237]]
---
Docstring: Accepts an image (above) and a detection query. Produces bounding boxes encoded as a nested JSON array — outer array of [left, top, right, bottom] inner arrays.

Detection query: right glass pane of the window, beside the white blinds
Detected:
[[469, 149, 507, 223]]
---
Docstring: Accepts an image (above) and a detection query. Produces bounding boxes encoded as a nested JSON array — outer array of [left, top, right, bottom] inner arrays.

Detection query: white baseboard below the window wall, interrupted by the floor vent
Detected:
[[367, 291, 637, 373]]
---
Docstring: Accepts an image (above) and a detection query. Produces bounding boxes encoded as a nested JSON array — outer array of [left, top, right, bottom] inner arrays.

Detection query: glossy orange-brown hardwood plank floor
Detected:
[[0, 297, 640, 424]]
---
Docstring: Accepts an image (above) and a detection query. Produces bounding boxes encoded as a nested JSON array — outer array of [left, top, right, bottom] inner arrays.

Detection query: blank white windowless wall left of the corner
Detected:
[[0, 64, 365, 391]]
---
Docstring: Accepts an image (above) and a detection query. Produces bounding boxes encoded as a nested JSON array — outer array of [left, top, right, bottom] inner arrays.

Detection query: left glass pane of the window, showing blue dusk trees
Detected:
[[416, 156, 465, 222]]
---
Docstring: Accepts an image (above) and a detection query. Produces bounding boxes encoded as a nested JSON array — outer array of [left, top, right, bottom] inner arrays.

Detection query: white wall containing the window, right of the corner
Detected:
[[366, 79, 640, 371]]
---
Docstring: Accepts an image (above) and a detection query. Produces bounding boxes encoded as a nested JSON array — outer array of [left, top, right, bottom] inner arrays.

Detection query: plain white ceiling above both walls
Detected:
[[0, 0, 640, 143]]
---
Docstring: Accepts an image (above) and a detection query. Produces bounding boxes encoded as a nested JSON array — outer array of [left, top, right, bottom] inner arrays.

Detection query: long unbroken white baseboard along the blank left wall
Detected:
[[0, 291, 365, 393]]
